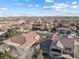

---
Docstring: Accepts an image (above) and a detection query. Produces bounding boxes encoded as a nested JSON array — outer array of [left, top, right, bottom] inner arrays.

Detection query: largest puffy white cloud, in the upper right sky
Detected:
[[43, 3, 68, 14]]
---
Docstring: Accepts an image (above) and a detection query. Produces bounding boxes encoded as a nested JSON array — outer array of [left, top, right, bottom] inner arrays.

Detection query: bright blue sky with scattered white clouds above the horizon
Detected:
[[0, 0, 79, 16]]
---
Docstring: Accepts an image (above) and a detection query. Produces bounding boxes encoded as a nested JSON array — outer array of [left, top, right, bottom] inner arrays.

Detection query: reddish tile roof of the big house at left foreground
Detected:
[[11, 32, 38, 46]]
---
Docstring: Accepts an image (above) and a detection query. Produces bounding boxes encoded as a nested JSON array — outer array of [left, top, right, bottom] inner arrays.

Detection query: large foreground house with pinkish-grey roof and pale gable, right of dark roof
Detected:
[[50, 34, 74, 56]]
